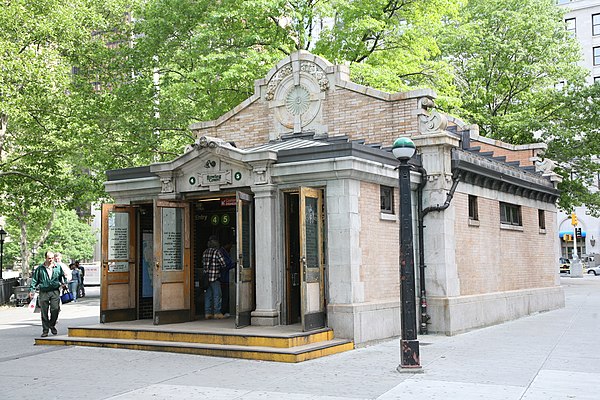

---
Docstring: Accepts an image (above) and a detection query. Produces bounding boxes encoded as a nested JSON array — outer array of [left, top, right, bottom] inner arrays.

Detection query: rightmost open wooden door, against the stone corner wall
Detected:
[[300, 188, 325, 331]]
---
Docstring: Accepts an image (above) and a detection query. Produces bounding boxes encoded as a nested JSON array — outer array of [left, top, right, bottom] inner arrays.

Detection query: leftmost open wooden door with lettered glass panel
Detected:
[[100, 204, 137, 323]]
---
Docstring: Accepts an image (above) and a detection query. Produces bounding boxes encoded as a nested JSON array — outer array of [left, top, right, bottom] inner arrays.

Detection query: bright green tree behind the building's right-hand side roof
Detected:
[[439, 0, 600, 210]]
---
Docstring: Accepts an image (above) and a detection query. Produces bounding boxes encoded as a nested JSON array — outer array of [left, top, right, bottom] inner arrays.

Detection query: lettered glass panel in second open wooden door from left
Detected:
[[161, 207, 183, 271]]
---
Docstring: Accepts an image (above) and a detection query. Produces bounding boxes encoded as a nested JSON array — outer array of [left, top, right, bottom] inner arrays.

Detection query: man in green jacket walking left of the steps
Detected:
[[29, 251, 67, 337]]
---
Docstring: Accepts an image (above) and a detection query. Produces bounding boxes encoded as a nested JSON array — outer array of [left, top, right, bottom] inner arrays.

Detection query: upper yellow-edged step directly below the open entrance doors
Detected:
[[68, 327, 334, 348]]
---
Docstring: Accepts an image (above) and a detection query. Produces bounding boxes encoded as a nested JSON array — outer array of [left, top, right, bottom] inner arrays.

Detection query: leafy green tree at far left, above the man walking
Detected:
[[0, 0, 134, 268]]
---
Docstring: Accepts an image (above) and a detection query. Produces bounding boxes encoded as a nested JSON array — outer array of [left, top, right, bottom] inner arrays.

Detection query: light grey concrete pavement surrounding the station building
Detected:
[[0, 276, 600, 400]]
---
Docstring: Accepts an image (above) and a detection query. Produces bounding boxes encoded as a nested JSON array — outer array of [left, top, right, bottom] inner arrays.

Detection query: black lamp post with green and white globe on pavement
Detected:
[[392, 137, 421, 371]]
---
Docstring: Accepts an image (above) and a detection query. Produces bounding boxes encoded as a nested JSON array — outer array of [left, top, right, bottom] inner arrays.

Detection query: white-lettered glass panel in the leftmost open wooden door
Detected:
[[108, 211, 129, 272]]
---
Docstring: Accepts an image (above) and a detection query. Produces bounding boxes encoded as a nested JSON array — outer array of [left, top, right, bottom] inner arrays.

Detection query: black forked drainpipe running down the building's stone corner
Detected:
[[415, 166, 460, 335]]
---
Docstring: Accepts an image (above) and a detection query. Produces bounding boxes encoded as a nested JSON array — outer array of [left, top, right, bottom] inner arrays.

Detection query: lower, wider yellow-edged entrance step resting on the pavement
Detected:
[[35, 336, 354, 363]]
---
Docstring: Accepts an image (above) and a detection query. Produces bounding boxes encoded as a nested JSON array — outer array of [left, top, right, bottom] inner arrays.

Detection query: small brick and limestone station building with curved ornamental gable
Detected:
[[101, 51, 564, 343]]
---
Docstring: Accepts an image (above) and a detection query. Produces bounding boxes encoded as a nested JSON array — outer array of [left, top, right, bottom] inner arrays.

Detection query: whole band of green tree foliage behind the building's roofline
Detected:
[[0, 0, 598, 222]]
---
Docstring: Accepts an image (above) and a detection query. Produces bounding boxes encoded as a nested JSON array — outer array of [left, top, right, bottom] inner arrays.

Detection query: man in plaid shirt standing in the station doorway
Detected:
[[202, 235, 226, 319]]
